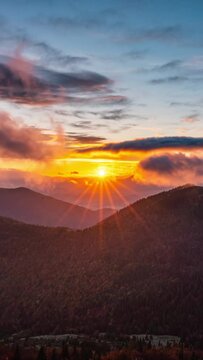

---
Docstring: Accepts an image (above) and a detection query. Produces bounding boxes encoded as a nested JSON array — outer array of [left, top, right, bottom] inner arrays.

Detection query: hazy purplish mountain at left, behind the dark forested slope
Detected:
[[0, 188, 114, 229]]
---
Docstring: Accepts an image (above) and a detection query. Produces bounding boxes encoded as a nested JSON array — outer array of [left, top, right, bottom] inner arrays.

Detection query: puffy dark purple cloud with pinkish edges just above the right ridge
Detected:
[[139, 153, 203, 175]]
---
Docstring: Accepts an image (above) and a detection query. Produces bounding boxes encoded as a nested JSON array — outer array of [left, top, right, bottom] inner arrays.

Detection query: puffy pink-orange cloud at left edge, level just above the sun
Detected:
[[0, 112, 61, 161]]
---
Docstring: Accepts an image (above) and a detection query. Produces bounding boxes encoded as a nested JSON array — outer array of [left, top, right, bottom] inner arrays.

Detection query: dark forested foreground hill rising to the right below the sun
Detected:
[[0, 186, 203, 335]]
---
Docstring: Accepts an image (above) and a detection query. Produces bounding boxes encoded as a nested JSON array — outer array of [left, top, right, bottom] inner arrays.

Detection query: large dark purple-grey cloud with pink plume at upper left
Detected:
[[0, 51, 127, 106]]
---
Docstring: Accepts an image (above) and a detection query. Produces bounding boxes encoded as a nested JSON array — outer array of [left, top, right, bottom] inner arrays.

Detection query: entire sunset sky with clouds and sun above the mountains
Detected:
[[0, 0, 203, 207]]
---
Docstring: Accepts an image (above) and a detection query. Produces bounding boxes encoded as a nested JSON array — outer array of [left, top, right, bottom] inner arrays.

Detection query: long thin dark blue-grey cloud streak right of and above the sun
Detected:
[[78, 136, 203, 152]]
